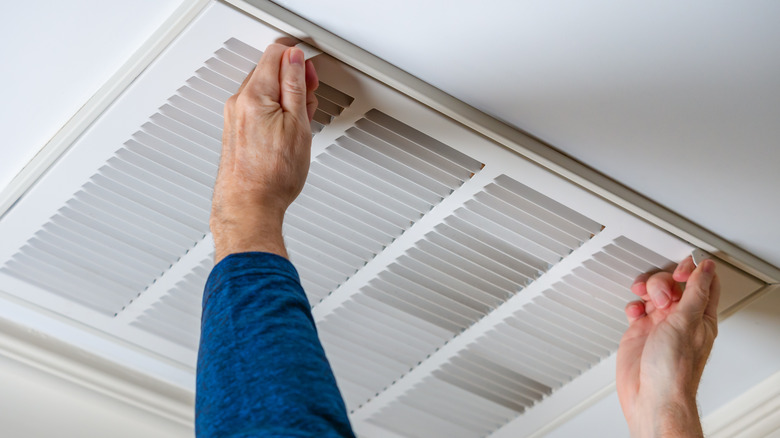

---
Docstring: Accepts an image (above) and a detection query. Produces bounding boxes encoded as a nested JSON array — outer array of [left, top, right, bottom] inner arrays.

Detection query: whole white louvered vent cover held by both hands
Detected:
[[0, 3, 759, 437]]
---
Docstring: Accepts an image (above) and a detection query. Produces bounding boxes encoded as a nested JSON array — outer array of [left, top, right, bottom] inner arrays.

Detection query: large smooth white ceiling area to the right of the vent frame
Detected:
[[276, 0, 780, 265]]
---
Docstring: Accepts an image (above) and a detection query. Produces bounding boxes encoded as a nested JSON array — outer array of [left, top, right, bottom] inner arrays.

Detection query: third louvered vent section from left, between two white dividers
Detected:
[[318, 175, 602, 409]]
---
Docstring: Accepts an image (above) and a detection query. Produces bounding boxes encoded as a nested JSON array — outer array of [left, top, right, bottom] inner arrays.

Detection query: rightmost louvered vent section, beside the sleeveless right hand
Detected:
[[370, 236, 671, 437]]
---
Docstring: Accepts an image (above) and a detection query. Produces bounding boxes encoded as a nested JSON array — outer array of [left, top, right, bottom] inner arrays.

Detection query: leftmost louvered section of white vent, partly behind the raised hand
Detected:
[[2, 38, 353, 314]]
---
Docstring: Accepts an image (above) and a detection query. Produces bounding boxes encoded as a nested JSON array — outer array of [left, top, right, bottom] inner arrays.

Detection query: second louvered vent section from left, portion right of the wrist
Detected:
[[285, 110, 482, 304]]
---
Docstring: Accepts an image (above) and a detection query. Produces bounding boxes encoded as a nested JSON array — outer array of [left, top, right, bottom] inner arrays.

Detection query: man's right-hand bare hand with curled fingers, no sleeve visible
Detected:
[[617, 257, 720, 438]]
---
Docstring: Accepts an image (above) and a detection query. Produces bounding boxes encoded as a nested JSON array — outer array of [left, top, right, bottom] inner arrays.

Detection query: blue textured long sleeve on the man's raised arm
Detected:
[[195, 252, 354, 438]]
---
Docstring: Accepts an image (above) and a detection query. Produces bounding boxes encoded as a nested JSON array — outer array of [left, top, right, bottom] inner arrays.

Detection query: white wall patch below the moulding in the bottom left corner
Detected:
[[0, 356, 194, 438]]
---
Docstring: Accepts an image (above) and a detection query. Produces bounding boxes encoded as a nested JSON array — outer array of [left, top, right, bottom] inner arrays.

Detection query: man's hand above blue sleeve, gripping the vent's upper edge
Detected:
[[209, 44, 319, 262]]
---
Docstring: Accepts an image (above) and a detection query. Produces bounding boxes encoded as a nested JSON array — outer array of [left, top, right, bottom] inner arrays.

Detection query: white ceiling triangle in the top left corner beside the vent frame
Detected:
[[0, 0, 182, 192]]
